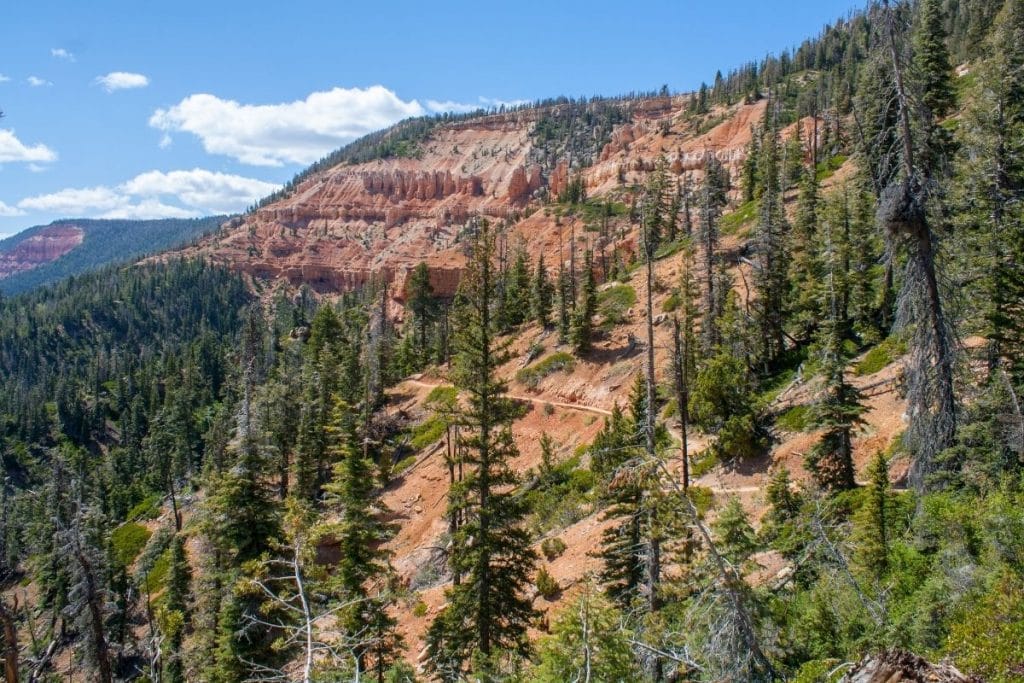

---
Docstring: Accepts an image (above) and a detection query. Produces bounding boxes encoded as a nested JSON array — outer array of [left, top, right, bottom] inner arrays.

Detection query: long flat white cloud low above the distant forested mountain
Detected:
[[17, 168, 278, 218]]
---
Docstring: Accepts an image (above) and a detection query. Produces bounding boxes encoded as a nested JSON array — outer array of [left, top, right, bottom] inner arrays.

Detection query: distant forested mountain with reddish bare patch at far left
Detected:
[[0, 216, 227, 294]]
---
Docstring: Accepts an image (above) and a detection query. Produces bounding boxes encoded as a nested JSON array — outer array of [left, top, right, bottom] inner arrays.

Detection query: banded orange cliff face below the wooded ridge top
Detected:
[[188, 97, 765, 303]]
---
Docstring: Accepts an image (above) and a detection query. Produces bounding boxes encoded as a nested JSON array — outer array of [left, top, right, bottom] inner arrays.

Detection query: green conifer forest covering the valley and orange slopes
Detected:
[[0, 0, 1024, 683]]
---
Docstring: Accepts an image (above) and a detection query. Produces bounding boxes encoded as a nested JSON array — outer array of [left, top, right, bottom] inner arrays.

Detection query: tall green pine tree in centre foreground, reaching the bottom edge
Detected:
[[427, 221, 537, 680]]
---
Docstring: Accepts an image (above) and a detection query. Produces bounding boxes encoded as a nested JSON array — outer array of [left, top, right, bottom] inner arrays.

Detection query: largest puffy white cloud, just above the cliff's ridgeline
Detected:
[[150, 85, 427, 166]]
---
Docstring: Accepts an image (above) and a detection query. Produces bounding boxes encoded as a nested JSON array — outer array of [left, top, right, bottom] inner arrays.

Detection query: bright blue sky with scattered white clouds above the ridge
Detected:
[[0, 0, 854, 238]]
